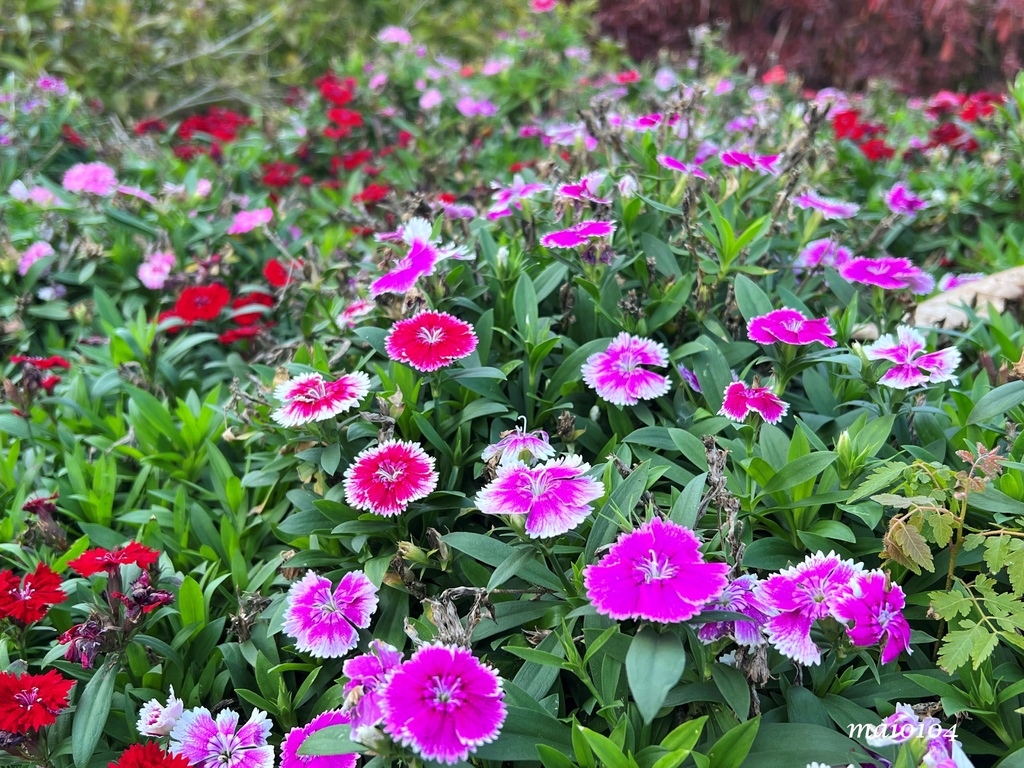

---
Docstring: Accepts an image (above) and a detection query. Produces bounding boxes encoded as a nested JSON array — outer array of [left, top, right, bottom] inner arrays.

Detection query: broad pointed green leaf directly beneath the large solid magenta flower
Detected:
[[622, 625, 686, 724]]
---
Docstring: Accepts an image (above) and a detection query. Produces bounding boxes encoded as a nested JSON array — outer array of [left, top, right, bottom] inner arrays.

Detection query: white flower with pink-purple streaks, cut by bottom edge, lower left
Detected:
[[169, 707, 274, 768]]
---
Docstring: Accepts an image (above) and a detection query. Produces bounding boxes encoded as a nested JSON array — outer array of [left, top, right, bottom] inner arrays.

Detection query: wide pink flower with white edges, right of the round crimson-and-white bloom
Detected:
[[476, 456, 604, 539]]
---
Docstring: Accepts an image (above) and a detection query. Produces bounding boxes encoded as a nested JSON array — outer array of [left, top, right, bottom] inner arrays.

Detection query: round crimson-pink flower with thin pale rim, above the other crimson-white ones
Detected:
[[384, 310, 476, 371]]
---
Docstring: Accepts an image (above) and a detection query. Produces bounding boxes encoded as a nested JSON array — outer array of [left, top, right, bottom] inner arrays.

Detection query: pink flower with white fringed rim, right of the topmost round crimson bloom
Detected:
[[582, 332, 671, 406]]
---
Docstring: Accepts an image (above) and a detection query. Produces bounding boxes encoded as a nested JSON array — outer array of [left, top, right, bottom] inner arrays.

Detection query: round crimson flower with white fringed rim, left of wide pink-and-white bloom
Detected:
[[345, 440, 437, 517]]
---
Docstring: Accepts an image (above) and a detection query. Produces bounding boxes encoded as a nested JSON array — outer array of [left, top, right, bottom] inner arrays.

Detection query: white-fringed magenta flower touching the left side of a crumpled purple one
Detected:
[[761, 552, 864, 665]]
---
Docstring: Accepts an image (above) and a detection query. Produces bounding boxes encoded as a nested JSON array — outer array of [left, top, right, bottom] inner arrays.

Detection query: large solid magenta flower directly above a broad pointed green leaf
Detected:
[[583, 517, 729, 624]]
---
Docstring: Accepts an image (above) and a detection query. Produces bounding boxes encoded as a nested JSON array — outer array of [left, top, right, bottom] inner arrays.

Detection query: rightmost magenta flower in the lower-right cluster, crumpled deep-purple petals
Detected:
[[833, 570, 910, 664]]
